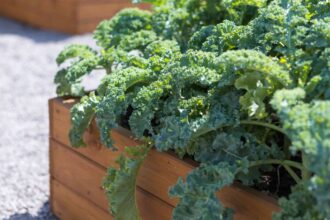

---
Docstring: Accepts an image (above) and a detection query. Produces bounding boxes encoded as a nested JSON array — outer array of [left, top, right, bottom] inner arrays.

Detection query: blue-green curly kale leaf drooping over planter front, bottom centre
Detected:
[[169, 163, 236, 220]]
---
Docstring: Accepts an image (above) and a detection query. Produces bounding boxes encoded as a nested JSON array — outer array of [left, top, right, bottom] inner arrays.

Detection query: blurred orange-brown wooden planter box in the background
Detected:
[[0, 0, 148, 34]]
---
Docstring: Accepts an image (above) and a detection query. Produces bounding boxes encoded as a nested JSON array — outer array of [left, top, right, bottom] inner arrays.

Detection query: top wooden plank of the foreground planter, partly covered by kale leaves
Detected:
[[49, 98, 279, 220]]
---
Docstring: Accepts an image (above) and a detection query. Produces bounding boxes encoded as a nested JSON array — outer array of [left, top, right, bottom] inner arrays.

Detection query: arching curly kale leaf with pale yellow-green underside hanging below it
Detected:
[[217, 50, 291, 119]]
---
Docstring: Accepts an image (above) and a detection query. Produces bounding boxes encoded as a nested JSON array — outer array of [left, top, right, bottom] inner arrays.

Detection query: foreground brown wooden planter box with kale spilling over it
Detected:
[[49, 98, 279, 220]]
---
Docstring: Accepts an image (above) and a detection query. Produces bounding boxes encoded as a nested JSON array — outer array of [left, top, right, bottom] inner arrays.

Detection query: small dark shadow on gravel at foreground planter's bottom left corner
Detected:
[[3, 202, 58, 220]]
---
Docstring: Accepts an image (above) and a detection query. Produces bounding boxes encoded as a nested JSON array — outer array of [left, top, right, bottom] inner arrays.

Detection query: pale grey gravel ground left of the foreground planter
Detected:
[[0, 18, 103, 220]]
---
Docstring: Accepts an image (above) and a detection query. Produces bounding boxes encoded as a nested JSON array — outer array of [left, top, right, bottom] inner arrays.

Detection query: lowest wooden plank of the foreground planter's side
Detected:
[[50, 179, 113, 220]]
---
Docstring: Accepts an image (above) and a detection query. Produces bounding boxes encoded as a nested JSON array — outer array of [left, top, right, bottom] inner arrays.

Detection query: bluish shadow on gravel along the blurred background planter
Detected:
[[0, 16, 72, 43]]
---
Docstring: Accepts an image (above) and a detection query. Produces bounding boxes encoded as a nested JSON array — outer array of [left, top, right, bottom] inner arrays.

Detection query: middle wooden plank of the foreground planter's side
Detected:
[[50, 140, 173, 220]]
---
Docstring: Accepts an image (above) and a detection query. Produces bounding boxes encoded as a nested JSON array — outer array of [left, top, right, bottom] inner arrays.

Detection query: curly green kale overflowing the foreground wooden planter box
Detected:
[[55, 0, 330, 220]]
